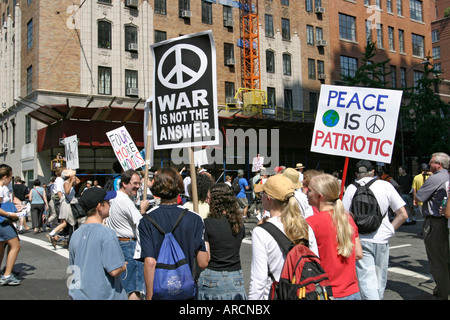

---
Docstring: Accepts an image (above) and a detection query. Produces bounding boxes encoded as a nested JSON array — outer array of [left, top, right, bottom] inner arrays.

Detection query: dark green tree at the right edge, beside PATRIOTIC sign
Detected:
[[400, 63, 450, 159]]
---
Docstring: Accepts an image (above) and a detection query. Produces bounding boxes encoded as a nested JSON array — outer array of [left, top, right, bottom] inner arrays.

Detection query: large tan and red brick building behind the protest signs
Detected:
[[0, 0, 432, 185]]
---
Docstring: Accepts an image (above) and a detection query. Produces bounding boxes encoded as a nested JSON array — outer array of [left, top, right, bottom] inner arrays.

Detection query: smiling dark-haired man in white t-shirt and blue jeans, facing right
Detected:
[[106, 170, 149, 300]]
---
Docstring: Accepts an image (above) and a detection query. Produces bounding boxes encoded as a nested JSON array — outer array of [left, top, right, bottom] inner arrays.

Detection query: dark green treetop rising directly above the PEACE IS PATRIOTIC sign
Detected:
[[342, 42, 390, 88]]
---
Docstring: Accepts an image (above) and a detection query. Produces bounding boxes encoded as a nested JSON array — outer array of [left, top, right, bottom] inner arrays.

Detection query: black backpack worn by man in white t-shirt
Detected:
[[350, 179, 385, 234]]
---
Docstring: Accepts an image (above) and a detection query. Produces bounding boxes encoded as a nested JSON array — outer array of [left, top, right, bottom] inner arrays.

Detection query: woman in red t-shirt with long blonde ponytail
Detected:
[[306, 174, 362, 300]]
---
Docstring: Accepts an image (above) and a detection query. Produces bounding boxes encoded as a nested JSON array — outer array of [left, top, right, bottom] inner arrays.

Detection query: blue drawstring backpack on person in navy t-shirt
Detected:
[[144, 209, 196, 300]]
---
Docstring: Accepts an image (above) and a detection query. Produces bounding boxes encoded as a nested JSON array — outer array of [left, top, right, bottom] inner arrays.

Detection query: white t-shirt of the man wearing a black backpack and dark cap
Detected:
[[342, 177, 406, 244]]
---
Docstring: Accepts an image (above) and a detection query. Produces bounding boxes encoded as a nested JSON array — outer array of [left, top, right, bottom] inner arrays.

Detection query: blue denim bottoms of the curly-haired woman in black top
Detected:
[[198, 269, 247, 300]]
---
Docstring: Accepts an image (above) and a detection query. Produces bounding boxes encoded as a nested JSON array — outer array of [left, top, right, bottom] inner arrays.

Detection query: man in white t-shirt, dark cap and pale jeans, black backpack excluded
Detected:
[[342, 160, 408, 300]]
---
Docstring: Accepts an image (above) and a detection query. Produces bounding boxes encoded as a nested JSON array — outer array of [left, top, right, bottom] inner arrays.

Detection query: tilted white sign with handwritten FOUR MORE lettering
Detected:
[[106, 127, 145, 171]]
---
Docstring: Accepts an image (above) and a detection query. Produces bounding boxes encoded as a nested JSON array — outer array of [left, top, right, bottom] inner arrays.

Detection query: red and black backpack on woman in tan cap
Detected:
[[261, 223, 333, 300]]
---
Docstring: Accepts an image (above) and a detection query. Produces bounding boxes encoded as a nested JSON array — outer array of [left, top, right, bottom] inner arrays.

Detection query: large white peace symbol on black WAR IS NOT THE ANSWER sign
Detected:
[[158, 44, 208, 89]]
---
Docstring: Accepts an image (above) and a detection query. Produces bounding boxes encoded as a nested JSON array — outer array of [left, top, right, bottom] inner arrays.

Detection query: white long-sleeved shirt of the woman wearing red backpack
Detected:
[[249, 217, 319, 300]]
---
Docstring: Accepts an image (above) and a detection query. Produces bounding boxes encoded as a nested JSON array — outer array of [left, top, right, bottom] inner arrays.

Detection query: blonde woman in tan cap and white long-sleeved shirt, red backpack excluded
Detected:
[[249, 174, 318, 300]]
